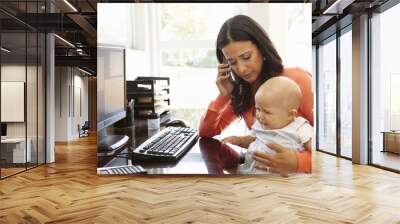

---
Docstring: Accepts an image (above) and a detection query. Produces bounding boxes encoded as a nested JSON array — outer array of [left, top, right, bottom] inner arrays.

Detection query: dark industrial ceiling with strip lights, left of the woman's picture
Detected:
[[0, 0, 100, 73]]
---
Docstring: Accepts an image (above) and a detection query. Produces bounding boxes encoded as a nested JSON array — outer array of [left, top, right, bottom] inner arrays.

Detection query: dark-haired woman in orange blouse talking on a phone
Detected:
[[199, 15, 314, 174]]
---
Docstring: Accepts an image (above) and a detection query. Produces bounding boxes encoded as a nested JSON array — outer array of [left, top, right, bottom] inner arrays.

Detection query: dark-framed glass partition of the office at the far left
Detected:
[[0, 1, 46, 179]]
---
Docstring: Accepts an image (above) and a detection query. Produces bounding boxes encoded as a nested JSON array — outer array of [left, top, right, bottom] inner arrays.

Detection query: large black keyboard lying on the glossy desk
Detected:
[[132, 127, 198, 162]]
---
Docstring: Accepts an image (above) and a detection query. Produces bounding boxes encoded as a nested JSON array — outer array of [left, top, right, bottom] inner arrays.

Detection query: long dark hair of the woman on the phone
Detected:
[[217, 15, 283, 116]]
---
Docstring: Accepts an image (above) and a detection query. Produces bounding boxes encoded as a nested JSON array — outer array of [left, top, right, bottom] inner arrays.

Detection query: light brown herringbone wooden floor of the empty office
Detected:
[[0, 138, 400, 224]]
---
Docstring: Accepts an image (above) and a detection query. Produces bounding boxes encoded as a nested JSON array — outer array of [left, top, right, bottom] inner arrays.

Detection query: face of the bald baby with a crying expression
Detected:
[[255, 97, 293, 130]]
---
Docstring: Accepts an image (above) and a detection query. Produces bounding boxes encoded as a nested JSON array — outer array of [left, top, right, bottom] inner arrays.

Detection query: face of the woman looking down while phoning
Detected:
[[222, 41, 263, 83]]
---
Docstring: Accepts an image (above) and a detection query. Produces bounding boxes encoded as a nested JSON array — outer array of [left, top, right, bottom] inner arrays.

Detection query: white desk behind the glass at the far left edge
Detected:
[[1, 138, 32, 163]]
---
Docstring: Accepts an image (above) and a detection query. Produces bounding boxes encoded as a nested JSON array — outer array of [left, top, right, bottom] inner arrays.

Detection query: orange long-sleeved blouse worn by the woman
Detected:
[[199, 67, 314, 173]]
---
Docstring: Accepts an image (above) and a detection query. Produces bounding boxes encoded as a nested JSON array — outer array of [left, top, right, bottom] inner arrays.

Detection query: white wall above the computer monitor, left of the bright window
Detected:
[[97, 3, 148, 80]]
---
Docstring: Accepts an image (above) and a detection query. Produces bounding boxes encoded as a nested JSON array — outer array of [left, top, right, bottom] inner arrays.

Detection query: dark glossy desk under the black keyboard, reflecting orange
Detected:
[[98, 121, 240, 175]]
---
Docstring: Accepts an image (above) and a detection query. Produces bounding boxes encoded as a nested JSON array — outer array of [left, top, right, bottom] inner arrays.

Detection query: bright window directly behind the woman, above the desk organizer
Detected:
[[155, 4, 247, 130]]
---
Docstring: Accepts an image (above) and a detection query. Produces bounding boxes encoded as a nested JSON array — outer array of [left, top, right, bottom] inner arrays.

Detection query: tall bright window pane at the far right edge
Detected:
[[371, 1, 400, 170]]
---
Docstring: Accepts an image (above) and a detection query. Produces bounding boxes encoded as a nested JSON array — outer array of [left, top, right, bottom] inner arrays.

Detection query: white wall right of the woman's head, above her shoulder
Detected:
[[248, 3, 312, 72]]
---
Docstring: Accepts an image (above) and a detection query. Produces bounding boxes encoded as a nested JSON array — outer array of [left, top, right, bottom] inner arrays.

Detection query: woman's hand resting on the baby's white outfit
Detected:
[[253, 144, 297, 177]]
